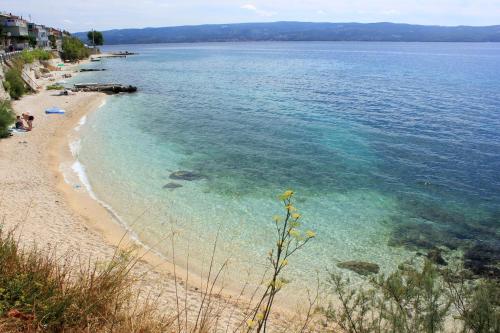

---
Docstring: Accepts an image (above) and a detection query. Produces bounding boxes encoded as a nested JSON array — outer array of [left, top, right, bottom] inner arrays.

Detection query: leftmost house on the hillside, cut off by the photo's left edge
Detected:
[[0, 14, 29, 51]]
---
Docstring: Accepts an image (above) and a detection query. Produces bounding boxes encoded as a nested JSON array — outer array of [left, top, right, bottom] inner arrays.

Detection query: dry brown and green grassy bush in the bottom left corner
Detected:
[[0, 230, 166, 332]]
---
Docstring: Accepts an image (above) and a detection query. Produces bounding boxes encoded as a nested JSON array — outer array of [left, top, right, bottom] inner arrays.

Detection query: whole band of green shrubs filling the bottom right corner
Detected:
[[324, 261, 500, 333]]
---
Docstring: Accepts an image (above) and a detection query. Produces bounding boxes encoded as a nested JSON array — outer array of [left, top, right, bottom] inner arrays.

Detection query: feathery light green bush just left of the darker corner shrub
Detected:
[[327, 262, 451, 333]]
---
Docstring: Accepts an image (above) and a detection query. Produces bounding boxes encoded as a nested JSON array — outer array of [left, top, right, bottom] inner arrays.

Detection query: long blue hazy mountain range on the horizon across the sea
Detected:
[[74, 22, 500, 44]]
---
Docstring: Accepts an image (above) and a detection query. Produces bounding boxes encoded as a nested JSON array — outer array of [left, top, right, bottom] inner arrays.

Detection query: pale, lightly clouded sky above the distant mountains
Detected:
[[0, 0, 500, 32]]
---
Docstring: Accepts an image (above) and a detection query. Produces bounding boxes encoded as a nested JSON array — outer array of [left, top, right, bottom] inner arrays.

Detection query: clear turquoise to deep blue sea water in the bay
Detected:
[[67, 42, 500, 288]]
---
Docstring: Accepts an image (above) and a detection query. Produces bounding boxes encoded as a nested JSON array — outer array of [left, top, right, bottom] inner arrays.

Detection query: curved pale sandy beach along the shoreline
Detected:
[[0, 59, 300, 328]]
